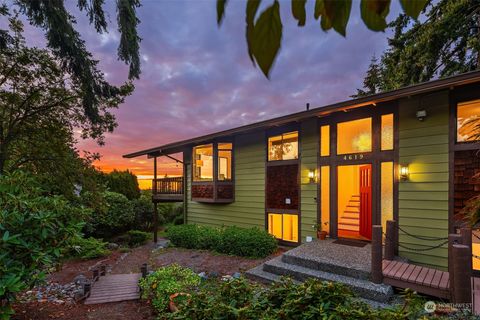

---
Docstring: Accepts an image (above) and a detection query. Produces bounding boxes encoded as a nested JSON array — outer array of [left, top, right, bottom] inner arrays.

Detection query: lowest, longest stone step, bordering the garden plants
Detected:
[[257, 257, 393, 303]]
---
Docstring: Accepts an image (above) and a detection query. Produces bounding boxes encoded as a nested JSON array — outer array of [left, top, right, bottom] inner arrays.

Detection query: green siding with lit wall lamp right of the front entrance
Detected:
[[398, 91, 449, 269]]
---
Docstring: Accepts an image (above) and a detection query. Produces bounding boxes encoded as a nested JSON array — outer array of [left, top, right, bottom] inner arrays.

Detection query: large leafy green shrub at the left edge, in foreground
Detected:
[[0, 171, 88, 318]]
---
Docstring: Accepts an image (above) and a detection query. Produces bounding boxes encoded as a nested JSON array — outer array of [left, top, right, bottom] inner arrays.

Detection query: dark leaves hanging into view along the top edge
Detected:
[[217, 0, 428, 78]]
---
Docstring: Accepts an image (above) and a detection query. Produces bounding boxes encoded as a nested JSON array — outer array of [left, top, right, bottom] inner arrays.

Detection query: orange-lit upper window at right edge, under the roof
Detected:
[[457, 100, 480, 142]]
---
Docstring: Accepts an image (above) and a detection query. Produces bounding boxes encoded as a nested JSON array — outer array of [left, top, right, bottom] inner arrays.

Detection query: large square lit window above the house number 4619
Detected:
[[337, 118, 372, 154]]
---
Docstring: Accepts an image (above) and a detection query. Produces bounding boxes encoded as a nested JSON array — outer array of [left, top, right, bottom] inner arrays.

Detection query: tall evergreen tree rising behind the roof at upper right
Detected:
[[356, 0, 480, 96]]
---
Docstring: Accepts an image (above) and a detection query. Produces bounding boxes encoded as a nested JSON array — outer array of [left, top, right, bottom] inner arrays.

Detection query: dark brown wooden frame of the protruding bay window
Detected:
[[190, 139, 235, 203]]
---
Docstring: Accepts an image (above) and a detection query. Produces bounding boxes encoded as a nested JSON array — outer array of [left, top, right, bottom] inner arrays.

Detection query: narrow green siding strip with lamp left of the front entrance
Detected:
[[300, 118, 319, 242]]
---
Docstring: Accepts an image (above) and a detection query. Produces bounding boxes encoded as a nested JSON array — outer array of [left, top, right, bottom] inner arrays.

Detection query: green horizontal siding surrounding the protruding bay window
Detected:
[[187, 132, 266, 229]]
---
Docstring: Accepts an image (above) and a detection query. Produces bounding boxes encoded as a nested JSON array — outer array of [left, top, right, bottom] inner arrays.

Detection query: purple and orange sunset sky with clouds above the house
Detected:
[[15, 0, 399, 188]]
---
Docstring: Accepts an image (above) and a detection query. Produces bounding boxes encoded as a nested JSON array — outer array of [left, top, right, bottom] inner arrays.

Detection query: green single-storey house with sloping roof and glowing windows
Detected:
[[125, 71, 480, 269]]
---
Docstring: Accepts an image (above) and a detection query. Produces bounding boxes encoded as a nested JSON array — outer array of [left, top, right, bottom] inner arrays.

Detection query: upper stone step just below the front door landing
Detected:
[[281, 252, 370, 280]]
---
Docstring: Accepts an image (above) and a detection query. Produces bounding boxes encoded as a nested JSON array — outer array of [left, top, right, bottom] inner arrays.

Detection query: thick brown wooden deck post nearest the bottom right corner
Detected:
[[453, 244, 472, 303]]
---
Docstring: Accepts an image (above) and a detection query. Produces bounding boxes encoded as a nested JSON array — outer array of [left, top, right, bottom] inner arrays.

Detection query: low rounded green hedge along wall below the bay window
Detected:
[[167, 224, 277, 258]]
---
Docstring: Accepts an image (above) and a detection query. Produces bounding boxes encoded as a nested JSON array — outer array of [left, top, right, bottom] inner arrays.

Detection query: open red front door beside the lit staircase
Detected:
[[359, 164, 372, 239]]
